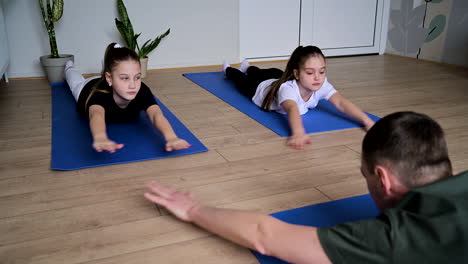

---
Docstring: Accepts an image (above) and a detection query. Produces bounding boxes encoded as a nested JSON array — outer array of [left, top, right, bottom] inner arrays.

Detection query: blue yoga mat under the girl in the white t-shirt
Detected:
[[184, 72, 380, 137]]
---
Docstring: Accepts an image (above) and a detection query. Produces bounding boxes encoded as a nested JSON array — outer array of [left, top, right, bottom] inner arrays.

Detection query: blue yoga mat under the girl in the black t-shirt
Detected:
[[51, 83, 208, 170]]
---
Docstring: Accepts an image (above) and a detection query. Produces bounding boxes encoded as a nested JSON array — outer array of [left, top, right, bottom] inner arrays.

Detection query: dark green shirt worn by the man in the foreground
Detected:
[[318, 171, 468, 264]]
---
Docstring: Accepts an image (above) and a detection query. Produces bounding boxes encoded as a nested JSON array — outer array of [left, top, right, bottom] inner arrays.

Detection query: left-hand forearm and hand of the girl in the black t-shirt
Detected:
[[88, 105, 124, 153]]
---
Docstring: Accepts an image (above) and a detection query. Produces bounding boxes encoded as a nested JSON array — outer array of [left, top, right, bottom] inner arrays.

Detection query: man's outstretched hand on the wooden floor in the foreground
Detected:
[[144, 182, 197, 222]]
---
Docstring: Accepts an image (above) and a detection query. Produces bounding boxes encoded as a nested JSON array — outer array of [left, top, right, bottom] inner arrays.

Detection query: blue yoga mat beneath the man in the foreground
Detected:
[[252, 194, 380, 264]]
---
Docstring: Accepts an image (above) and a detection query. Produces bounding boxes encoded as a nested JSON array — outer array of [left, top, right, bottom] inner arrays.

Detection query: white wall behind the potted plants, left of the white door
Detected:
[[0, 0, 239, 77]]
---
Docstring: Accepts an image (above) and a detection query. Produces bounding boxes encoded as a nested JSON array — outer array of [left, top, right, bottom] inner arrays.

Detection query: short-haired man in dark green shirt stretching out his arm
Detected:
[[145, 112, 468, 263]]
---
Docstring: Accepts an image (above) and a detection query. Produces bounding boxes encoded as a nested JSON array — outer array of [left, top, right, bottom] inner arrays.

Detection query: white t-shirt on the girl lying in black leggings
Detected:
[[252, 78, 337, 115]]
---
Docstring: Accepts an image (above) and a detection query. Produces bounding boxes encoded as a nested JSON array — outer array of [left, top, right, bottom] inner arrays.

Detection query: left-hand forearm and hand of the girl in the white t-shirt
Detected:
[[281, 100, 312, 149]]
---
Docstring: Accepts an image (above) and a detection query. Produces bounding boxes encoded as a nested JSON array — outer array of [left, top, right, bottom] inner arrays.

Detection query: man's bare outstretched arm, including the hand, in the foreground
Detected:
[[144, 182, 331, 263]]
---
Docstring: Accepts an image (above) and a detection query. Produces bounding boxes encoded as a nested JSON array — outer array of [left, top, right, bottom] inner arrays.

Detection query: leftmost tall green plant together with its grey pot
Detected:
[[39, 0, 74, 83]]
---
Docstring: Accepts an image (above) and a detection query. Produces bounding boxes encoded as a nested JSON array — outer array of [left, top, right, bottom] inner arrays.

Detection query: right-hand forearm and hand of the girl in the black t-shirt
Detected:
[[146, 105, 190, 151]]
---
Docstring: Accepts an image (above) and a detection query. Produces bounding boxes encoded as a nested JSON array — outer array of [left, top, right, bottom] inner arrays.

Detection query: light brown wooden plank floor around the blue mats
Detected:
[[0, 55, 468, 264]]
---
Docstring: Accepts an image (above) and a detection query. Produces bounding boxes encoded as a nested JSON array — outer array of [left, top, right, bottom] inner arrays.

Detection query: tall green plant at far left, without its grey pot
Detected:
[[39, 0, 63, 58]]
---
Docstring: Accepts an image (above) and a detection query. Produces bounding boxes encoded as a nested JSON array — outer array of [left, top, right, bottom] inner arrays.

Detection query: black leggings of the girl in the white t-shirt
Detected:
[[226, 66, 283, 98]]
